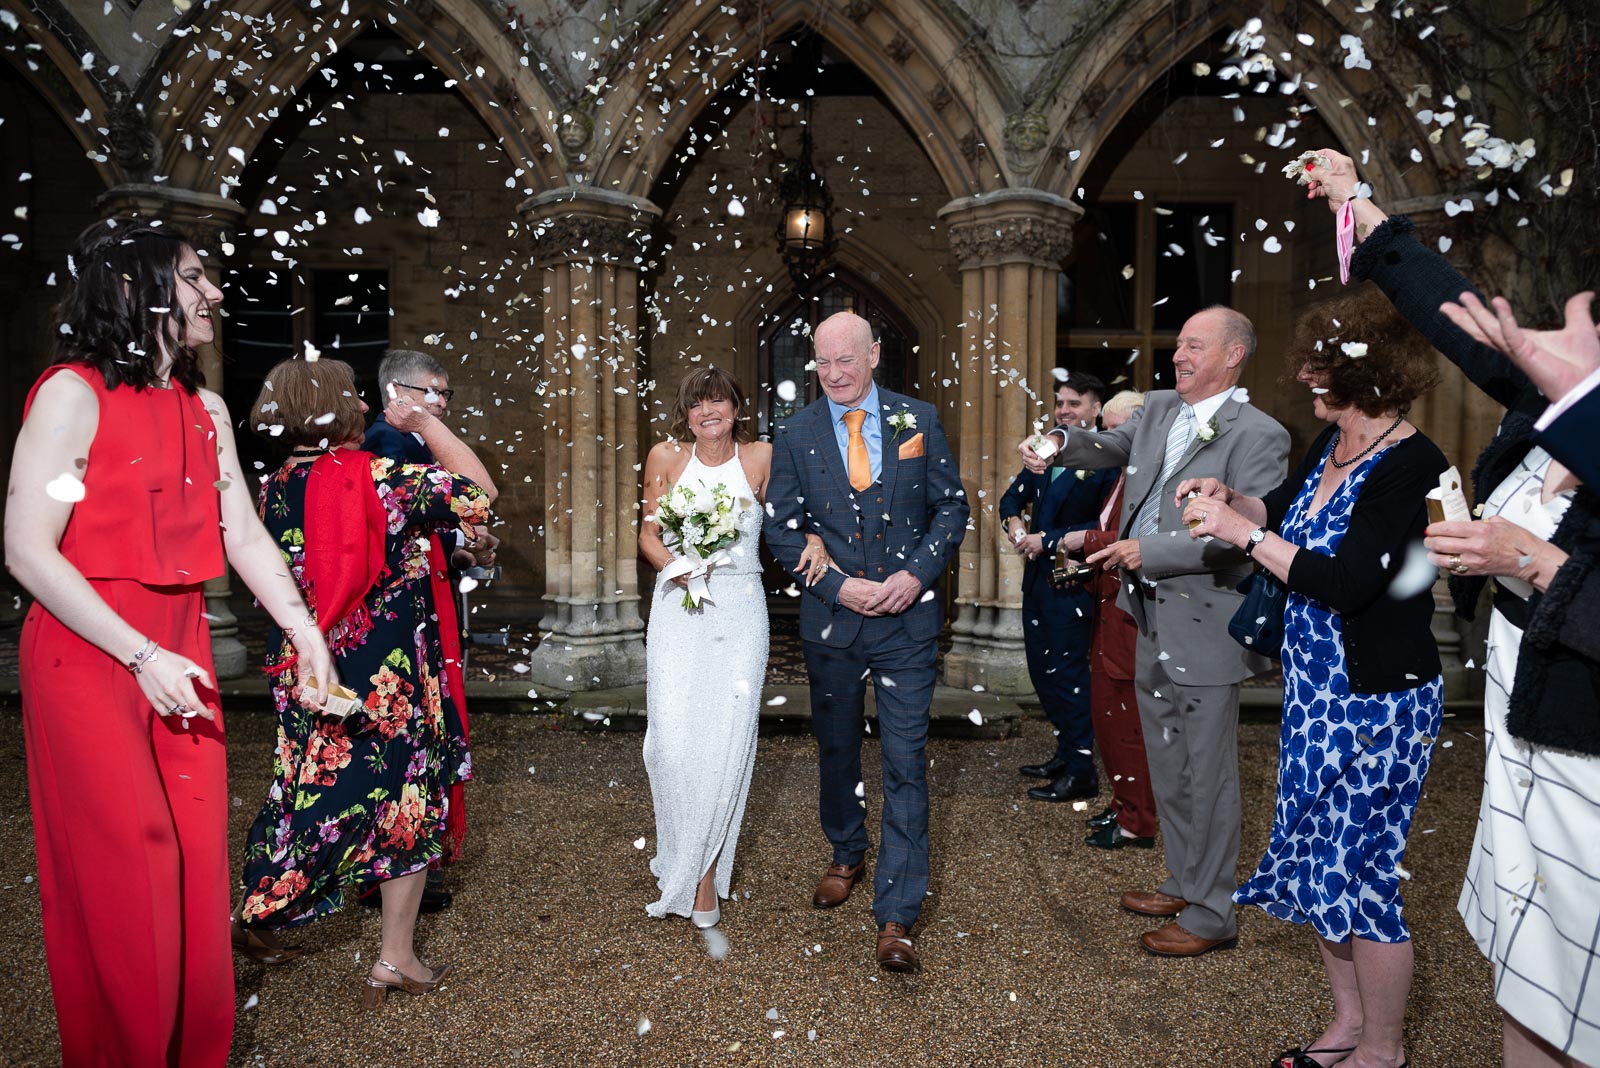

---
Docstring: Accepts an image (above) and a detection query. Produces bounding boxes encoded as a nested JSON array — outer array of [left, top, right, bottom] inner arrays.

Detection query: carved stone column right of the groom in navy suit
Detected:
[[939, 189, 1082, 694]]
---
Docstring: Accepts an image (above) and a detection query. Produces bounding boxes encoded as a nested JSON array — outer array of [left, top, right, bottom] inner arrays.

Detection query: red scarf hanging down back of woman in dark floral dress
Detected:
[[304, 449, 389, 651]]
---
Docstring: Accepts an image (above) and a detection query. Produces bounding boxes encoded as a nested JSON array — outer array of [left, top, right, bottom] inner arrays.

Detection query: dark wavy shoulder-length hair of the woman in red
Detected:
[[56, 217, 203, 393]]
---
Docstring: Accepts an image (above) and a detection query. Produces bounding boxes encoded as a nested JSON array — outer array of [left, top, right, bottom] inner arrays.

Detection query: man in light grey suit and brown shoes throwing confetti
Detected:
[[1019, 307, 1290, 956]]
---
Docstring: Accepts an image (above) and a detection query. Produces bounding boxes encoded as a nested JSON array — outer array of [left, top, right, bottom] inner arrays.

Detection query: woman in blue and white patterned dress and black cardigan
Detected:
[[1178, 282, 1446, 1068]]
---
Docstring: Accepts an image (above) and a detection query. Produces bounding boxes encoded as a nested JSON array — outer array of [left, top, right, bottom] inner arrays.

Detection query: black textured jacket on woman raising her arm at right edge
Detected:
[[1350, 216, 1600, 756]]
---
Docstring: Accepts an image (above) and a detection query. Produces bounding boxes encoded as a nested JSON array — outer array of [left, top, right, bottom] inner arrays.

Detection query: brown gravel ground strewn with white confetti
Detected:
[[0, 707, 1499, 1068]]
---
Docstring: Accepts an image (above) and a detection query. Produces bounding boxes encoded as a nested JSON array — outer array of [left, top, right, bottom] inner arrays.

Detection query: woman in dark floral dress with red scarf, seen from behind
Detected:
[[243, 360, 493, 1006]]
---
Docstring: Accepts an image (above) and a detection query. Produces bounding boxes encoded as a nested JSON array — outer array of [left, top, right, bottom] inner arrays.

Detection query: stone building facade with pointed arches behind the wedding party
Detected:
[[0, 0, 1536, 692]]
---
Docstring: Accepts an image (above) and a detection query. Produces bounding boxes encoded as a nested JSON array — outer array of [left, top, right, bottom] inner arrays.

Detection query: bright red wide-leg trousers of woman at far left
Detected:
[[21, 580, 234, 1068]]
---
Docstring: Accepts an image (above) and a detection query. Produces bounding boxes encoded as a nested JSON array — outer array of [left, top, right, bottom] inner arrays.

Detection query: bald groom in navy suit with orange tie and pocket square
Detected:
[[765, 312, 968, 972]]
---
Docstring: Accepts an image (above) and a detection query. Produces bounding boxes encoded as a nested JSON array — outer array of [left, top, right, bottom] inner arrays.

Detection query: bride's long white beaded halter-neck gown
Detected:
[[645, 449, 768, 918]]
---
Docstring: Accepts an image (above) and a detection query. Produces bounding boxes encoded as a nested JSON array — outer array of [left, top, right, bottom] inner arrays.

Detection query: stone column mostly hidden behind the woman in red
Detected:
[[99, 184, 248, 678]]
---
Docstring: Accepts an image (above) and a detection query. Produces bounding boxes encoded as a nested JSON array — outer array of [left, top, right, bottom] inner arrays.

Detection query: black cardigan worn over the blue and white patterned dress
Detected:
[[1262, 425, 1450, 694]]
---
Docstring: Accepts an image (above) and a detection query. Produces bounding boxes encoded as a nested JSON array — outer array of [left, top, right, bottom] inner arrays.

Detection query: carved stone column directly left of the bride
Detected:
[[522, 187, 661, 691]]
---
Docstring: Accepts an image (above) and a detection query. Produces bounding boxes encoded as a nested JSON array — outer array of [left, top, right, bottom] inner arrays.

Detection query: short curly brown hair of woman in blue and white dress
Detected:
[[1285, 283, 1438, 416]]
